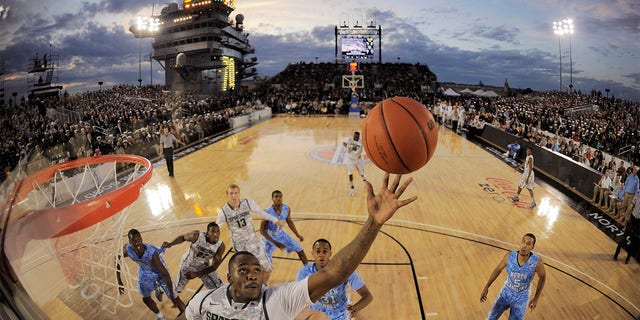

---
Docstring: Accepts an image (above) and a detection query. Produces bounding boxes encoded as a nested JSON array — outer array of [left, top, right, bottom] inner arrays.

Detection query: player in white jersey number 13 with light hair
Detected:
[[216, 184, 287, 280]]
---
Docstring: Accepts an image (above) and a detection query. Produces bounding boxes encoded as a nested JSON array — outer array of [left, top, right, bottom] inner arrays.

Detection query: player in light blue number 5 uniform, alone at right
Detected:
[[480, 233, 547, 320]]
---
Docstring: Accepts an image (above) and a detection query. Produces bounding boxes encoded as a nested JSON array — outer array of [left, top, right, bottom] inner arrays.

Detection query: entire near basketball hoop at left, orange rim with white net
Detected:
[[4, 154, 153, 314]]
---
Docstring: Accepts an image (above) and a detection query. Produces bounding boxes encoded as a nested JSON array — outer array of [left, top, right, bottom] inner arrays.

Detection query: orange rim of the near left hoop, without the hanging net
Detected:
[[9, 154, 152, 239]]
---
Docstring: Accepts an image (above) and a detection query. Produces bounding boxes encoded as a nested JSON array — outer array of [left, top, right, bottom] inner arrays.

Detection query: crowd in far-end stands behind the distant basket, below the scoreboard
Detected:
[[254, 62, 437, 115]]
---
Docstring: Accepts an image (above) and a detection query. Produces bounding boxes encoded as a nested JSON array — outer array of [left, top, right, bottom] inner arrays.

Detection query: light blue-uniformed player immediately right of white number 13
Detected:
[[260, 190, 309, 265]]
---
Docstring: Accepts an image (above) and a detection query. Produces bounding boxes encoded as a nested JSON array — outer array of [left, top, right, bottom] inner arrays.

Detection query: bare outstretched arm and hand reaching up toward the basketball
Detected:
[[308, 173, 418, 302]]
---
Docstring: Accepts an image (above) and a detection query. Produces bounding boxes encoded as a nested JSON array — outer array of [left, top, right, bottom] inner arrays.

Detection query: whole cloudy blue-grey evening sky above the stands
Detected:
[[0, 0, 640, 101]]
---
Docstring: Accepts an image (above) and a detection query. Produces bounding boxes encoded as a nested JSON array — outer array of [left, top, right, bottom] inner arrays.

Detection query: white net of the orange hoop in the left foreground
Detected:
[[12, 161, 149, 318]]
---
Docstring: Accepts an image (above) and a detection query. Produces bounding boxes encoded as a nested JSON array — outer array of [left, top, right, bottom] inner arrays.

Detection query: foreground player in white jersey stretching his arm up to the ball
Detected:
[[185, 173, 417, 320]]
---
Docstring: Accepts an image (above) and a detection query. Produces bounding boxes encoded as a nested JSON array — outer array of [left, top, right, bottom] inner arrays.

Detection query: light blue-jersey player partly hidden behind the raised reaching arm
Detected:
[[296, 239, 373, 320]]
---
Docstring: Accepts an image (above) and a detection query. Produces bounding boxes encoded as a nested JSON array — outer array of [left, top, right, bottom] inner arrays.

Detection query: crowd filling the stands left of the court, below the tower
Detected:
[[0, 85, 264, 186]]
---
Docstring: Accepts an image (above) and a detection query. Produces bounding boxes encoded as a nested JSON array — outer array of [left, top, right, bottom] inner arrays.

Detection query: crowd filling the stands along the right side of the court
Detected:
[[456, 92, 640, 172]]
